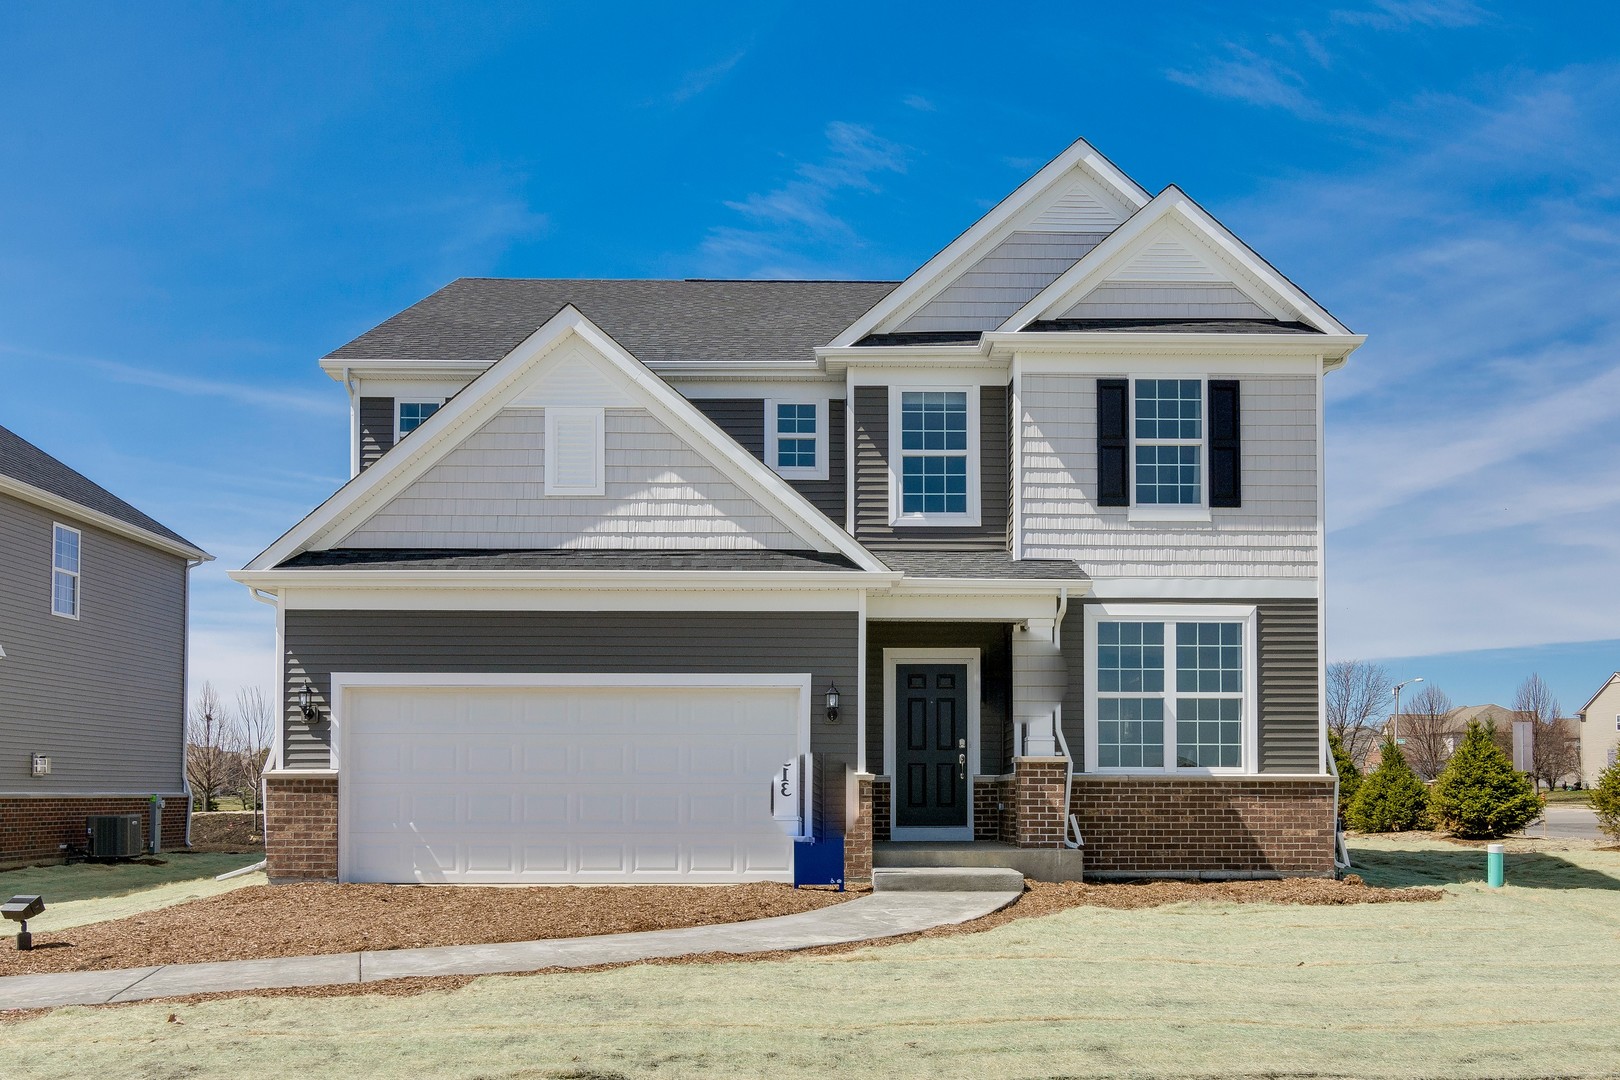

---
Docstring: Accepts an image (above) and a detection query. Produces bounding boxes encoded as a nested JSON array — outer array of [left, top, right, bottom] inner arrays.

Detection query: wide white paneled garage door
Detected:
[[339, 685, 805, 882]]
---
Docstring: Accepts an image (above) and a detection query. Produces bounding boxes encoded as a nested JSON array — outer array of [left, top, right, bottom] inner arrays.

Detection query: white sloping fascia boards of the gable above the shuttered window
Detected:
[[996, 185, 1353, 337]]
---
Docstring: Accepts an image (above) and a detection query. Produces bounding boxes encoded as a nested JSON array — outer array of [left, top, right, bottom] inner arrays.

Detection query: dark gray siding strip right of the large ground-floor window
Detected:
[[1259, 601, 1322, 772]]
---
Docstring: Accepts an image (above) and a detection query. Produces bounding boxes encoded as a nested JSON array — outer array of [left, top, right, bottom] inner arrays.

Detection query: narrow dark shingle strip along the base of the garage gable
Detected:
[[280, 547, 859, 570]]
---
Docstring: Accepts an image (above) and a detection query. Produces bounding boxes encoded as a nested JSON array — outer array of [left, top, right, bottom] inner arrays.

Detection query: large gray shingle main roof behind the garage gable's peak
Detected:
[[329, 277, 899, 363]]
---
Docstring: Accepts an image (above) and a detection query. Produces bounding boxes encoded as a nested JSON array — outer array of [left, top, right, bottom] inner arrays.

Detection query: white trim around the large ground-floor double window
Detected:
[[1085, 604, 1260, 776]]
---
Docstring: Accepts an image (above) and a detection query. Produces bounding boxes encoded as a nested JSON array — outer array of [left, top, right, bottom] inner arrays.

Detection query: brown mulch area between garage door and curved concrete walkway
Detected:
[[0, 881, 859, 976]]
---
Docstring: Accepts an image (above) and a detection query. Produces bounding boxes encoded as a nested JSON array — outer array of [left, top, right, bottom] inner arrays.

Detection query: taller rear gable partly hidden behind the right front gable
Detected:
[[831, 139, 1149, 348]]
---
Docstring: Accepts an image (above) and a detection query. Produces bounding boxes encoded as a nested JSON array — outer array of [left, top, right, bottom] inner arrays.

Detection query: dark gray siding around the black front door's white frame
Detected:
[[867, 622, 1013, 776]]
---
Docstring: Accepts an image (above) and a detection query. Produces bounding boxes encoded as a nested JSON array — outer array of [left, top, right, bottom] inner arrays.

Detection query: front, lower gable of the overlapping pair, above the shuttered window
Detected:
[[998, 186, 1349, 335]]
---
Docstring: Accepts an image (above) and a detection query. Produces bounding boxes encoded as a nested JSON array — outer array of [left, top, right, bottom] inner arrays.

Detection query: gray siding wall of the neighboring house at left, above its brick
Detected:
[[0, 495, 186, 795]]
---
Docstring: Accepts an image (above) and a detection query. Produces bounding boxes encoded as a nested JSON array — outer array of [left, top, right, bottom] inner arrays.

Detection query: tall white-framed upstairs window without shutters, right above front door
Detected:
[[889, 389, 978, 525]]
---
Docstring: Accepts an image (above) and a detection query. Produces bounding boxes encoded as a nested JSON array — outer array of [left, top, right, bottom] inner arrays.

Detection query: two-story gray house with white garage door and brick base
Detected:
[[235, 142, 1362, 882]]
